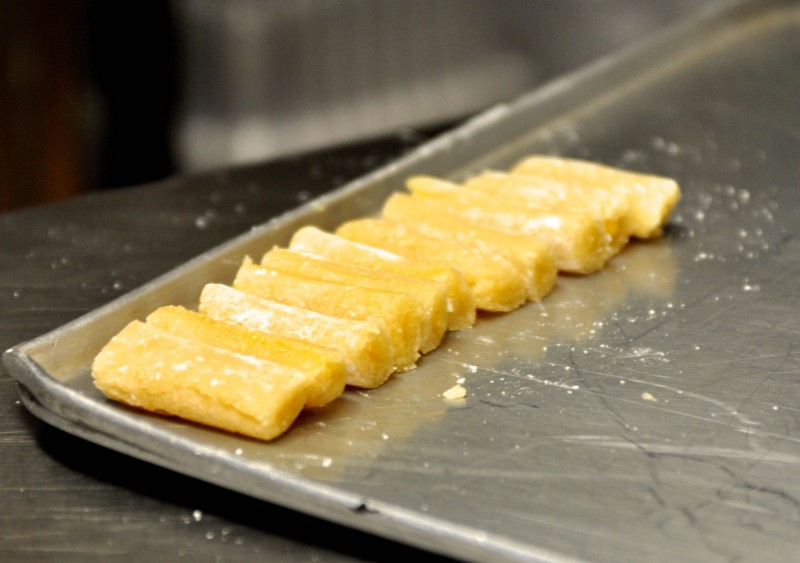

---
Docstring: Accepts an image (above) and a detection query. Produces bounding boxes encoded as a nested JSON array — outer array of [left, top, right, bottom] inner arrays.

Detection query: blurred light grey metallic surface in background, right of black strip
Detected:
[[173, 0, 716, 170]]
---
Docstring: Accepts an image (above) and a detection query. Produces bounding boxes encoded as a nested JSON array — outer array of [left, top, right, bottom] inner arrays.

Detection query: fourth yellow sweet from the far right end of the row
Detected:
[[383, 193, 558, 301]]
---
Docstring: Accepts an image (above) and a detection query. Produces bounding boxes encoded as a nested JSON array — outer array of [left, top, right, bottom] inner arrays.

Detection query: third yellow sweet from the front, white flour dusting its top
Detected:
[[199, 284, 394, 388]]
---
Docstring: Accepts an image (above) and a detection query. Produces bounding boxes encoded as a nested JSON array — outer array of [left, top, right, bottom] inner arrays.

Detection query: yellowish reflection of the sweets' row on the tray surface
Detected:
[[256, 235, 676, 482]]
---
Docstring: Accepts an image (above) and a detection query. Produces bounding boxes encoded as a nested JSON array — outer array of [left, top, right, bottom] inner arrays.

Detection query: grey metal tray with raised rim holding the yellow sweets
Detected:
[[4, 1, 800, 561]]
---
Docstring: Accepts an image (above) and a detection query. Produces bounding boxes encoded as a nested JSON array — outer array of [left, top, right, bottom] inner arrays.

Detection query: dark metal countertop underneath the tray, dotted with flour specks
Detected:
[[0, 131, 450, 561]]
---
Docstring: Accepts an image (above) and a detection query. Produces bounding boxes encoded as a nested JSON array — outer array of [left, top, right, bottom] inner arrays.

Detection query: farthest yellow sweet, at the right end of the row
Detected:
[[512, 156, 681, 238]]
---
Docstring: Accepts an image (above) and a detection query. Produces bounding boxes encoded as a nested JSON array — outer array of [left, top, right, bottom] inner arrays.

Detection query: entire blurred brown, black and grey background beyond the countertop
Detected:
[[0, 0, 715, 210]]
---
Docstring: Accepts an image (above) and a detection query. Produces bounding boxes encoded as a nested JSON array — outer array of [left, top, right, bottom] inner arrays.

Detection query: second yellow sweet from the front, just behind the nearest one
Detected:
[[147, 306, 347, 407]]
